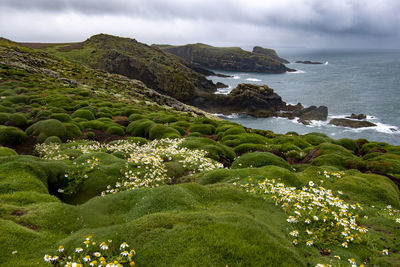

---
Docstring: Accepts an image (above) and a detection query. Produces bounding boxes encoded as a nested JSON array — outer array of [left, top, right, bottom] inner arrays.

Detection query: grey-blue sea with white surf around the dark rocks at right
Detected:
[[209, 49, 400, 145]]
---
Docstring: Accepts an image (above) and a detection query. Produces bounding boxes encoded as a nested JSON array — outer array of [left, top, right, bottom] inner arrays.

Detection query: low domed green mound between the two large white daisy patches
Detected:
[[232, 152, 292, 170]]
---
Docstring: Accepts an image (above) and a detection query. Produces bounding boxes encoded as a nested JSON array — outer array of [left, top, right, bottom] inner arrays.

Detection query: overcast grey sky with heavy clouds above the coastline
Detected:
[[0, 0, 400, 49]]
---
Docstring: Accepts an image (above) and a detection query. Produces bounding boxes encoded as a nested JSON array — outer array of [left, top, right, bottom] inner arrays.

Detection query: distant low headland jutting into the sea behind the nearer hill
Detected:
[[157, 44, 291, 73]]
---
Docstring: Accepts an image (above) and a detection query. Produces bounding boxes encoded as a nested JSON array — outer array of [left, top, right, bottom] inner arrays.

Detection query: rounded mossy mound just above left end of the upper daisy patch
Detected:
[[26, 119, 67, 142]]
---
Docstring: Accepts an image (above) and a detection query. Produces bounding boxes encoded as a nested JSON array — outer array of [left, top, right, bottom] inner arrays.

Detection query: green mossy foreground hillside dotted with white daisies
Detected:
[[0, 36, 400, 266]]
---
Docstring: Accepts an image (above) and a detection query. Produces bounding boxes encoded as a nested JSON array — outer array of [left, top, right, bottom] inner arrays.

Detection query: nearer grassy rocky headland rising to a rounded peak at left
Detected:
[[24, 34, 216, 102]]
